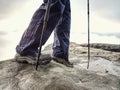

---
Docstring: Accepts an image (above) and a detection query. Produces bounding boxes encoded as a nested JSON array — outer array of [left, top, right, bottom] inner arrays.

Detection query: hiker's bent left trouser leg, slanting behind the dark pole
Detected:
[[16, 0, 64, 56]]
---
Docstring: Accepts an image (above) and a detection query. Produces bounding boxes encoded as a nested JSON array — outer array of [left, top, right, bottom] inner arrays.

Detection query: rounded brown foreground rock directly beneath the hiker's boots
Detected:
[[0, 60, 120, 90]]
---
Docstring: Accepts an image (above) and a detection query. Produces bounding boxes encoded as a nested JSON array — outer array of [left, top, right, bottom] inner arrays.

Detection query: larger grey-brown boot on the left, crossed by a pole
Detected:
[[15, 54, 51, 65]]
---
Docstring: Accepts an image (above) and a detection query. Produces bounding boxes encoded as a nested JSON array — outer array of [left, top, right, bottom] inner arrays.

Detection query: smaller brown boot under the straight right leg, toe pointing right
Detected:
[[52, 56, 73, 68]]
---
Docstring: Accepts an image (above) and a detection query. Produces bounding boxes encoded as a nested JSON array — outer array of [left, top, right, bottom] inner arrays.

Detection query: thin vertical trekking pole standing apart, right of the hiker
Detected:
[[87, 0, 90, 69]]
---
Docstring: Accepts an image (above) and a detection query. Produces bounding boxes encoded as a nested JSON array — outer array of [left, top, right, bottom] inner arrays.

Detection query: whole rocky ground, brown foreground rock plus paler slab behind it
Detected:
[[0, 43, 120, 90]]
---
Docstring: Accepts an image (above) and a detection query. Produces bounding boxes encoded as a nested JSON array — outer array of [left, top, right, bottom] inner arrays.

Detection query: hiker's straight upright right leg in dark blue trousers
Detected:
[[53, 0, 71, 60]]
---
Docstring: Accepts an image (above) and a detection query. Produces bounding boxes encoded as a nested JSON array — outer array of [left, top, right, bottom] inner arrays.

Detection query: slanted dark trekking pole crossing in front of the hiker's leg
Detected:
[[36, 0, 52, 70]]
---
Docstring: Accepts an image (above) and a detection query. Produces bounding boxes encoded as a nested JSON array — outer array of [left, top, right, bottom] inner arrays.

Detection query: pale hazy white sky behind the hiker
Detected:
[[0, 0, 120, 60]]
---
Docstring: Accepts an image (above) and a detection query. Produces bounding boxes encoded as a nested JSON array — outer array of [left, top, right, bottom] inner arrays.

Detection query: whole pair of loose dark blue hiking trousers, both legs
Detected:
[[16, 0, 71, 59]]
